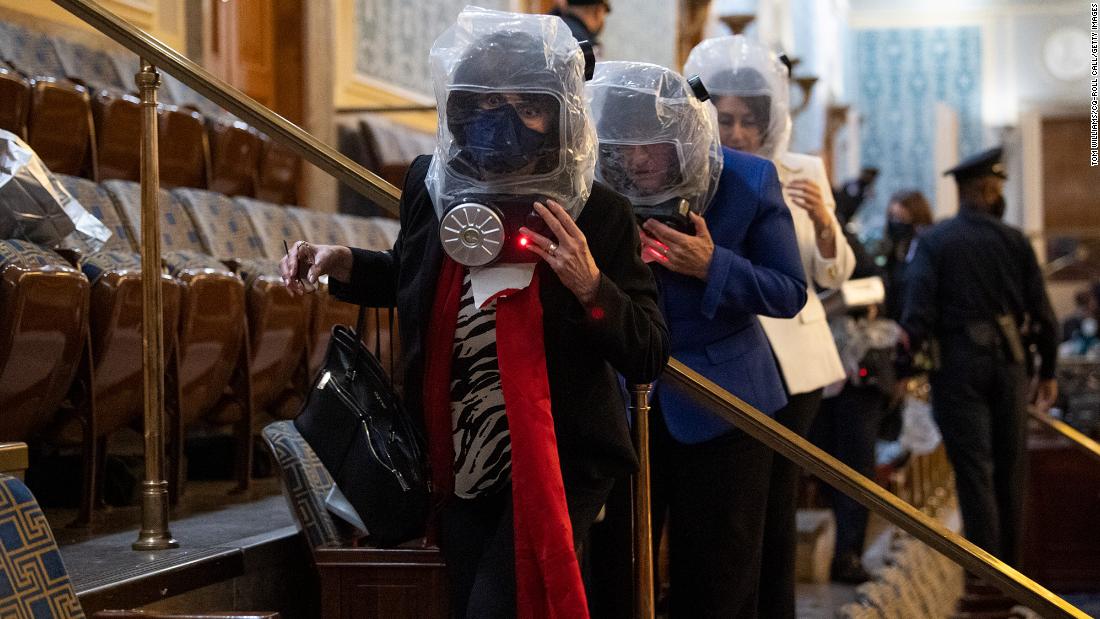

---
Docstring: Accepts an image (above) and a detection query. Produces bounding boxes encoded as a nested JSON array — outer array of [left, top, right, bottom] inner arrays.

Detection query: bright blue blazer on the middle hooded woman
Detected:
[[655, 148, 806, 443]]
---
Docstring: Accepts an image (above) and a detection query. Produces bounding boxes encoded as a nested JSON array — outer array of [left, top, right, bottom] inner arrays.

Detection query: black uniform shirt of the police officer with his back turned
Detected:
[[901, 208, 1058, 378]]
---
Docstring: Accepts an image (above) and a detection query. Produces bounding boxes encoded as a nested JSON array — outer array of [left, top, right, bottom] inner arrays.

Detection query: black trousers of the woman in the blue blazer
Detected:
[[650, 398, 772, 619]]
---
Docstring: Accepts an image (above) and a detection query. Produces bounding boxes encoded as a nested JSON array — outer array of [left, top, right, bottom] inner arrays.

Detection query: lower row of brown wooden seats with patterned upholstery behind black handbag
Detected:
[[0, 176, 396, 517]]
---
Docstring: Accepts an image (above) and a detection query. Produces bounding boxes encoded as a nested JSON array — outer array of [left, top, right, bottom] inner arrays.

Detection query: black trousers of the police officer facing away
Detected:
[[931, 336, 1027, 565]]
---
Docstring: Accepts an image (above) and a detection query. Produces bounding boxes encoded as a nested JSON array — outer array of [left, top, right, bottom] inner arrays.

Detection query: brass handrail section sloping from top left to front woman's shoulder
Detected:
[[53, 0, 400, 214]]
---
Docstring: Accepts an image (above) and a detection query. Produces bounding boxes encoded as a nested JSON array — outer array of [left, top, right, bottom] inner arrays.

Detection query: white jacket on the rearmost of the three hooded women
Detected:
[[760, 153, 856, 395]]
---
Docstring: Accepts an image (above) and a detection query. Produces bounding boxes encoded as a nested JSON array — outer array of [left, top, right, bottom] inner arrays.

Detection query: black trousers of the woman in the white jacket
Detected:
[[758, 389, 822, 619]]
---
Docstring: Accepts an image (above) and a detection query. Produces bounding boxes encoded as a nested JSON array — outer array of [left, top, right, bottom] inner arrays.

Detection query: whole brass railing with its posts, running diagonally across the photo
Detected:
[[45, 0, 1088, 618]]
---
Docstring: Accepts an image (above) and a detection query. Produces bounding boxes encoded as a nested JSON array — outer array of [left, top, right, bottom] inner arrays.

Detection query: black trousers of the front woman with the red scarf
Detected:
[[439, 479, 612, 619]]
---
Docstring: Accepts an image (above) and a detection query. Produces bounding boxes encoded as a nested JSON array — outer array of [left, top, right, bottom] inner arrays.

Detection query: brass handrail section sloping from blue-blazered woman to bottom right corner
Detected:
[[661, 358, 1089, 619]]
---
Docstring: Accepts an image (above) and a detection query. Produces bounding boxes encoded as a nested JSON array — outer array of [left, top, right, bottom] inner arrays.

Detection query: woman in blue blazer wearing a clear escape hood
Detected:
[[589, 63, 806, 619]]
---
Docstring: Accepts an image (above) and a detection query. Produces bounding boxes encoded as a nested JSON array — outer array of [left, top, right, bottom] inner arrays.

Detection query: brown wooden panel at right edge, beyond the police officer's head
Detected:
[[1043, 115, 1100, 235]]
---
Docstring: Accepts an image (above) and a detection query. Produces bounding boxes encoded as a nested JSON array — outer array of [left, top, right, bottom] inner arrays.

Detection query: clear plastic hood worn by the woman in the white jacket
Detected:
[[684, 34, 791, 161]]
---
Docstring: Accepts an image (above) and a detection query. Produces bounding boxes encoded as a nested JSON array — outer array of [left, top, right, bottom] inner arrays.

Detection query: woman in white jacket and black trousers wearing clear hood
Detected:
[[684, 35, 856, 618]]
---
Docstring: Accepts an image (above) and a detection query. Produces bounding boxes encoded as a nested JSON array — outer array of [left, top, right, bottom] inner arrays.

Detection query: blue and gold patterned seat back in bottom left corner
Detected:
[[0, 474, 85, 619]]
